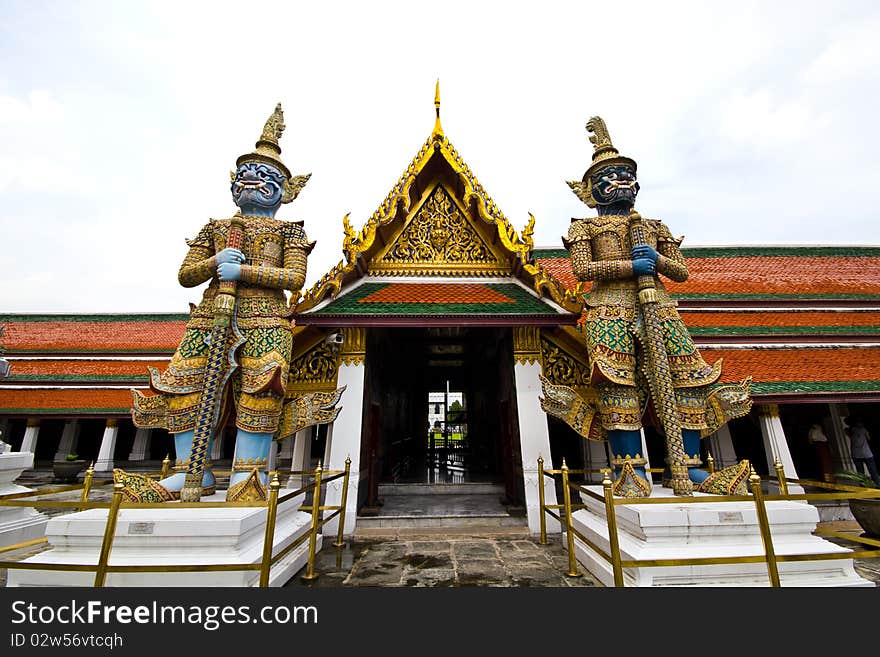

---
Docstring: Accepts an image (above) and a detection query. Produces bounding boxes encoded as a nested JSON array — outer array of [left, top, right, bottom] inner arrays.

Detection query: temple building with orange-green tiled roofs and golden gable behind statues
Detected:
[[0, 101, 880, 530]]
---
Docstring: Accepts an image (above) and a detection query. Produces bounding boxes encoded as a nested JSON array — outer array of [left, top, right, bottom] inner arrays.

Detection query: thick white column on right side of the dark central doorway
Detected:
[[513, 358, 560, 534]]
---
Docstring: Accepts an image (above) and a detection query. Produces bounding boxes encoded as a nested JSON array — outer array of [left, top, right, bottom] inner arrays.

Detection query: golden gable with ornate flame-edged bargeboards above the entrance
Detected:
[[296, 88, 582, 313]]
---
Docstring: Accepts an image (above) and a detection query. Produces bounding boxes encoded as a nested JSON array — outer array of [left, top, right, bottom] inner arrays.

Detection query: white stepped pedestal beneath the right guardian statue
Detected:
[[563, 486, 874, 587]]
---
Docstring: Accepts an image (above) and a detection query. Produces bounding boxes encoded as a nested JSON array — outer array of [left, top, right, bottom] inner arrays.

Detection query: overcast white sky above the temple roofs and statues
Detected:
[[0, 0, 880, 313]]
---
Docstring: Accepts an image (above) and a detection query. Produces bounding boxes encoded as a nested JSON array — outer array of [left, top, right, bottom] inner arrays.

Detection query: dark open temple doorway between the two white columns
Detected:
[[359, 326, 523, 514]]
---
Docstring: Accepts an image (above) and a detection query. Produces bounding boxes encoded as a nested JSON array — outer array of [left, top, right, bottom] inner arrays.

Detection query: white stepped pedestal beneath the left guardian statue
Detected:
[[7, 491, 321, 587]]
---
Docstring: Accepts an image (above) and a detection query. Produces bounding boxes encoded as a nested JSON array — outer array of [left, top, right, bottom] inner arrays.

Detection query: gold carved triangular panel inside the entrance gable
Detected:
[[370, 185, 508, 274]]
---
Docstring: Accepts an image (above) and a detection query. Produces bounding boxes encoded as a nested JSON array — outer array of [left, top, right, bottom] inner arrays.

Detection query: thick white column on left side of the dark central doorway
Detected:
[[323, 362, 364, 535]]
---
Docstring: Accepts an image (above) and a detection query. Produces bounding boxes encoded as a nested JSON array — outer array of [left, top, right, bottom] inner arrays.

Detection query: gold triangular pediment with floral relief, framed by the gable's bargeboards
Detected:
[[368, 182, 510, 275]]
